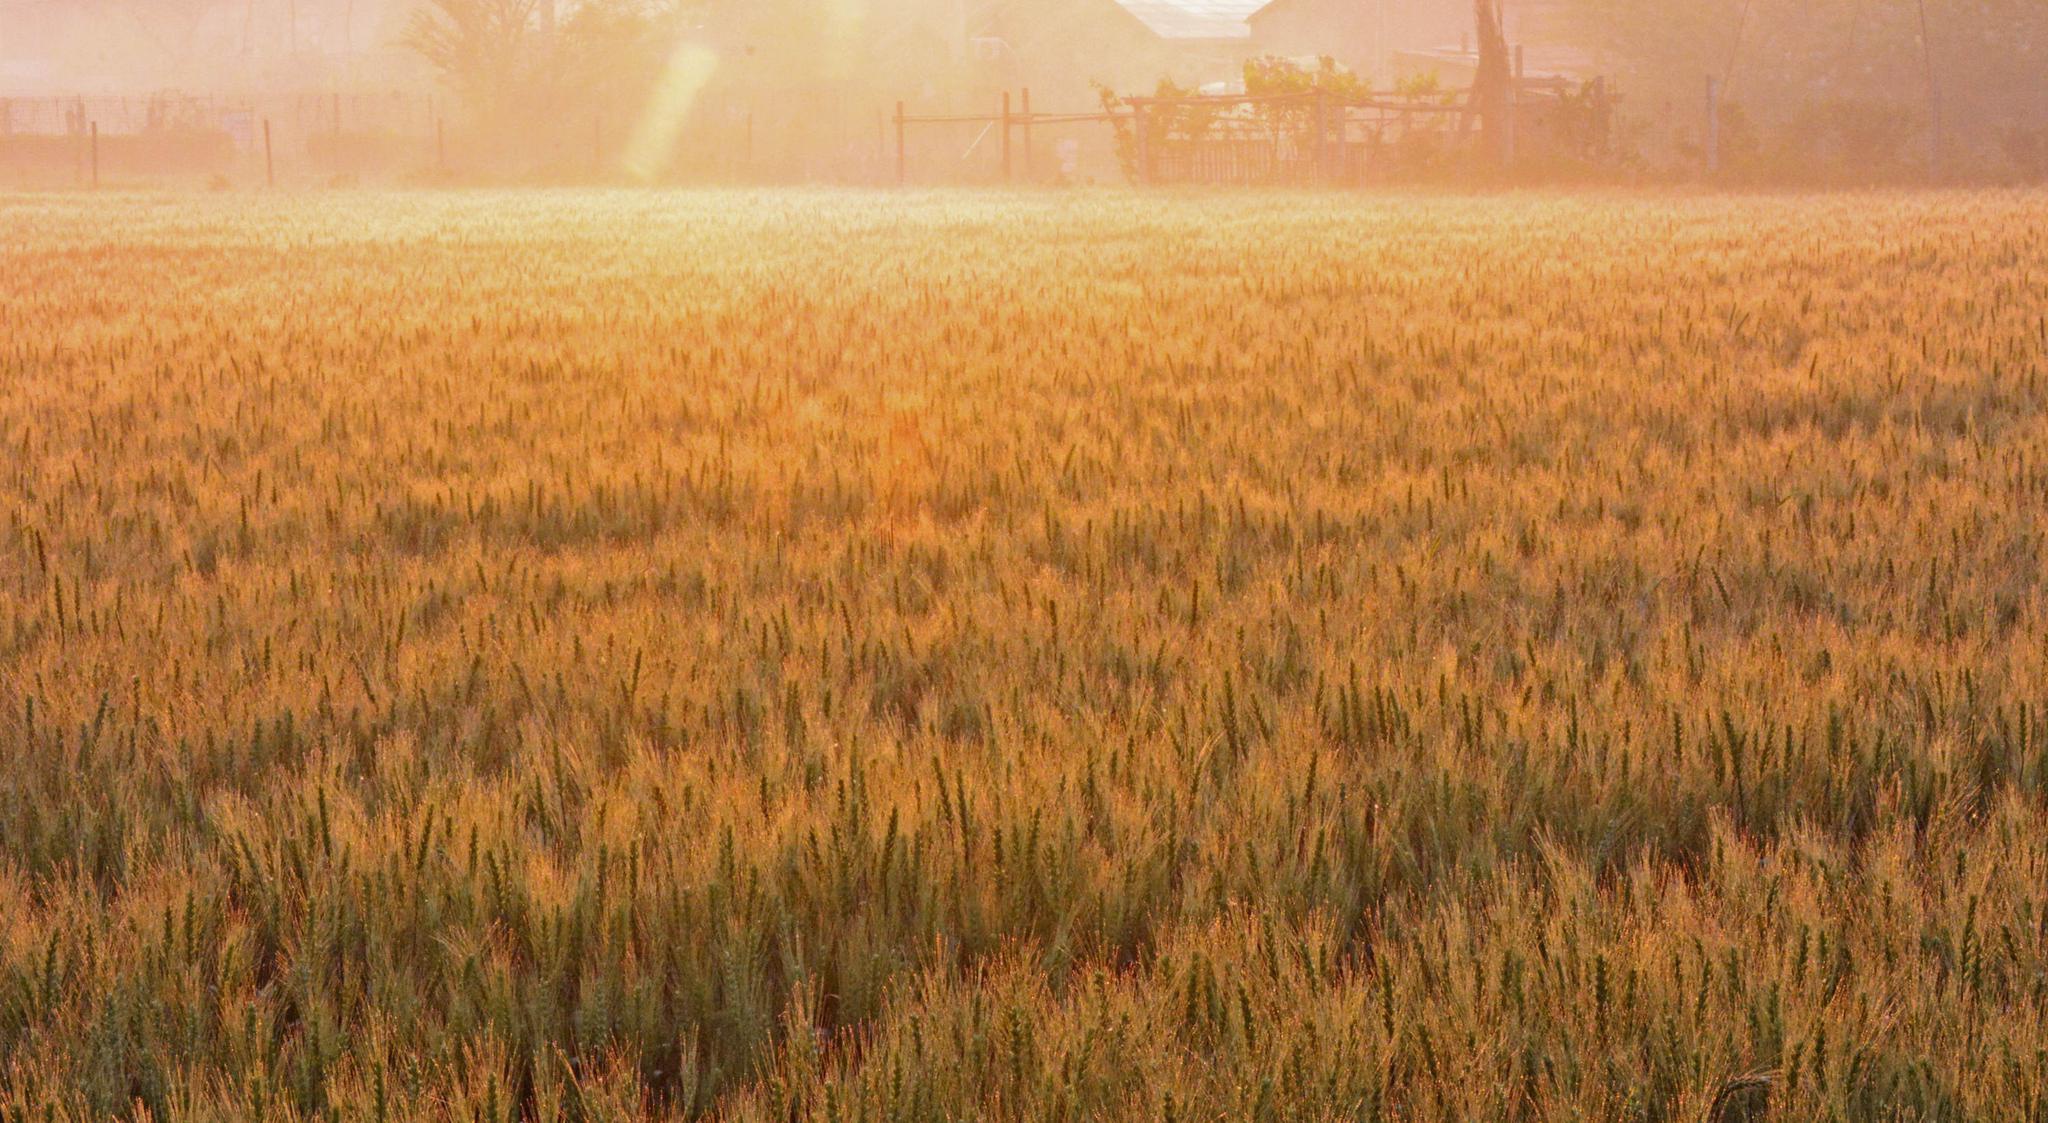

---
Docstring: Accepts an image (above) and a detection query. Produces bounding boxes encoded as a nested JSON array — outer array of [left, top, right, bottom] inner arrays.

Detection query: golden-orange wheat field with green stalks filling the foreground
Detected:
[[0, 191, 2048, 1121]]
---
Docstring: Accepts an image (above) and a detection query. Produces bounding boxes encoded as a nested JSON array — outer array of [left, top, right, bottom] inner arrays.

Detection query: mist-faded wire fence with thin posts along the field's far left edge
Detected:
[[0, 90, 913, 186]]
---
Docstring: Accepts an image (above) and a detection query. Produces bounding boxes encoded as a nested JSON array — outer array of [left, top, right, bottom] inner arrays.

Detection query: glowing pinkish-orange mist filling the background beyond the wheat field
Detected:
[[0, 0, 2048, 186]]
